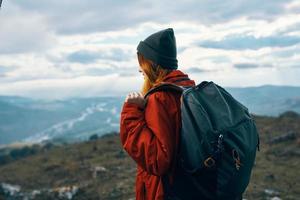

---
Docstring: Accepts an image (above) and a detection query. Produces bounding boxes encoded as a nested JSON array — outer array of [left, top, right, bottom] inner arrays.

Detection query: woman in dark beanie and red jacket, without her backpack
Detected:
[[120, 28, 195, 200]]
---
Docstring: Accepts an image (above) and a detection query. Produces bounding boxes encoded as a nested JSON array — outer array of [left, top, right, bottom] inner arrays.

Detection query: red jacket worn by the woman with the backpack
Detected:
[[120, 70, 195, 200]]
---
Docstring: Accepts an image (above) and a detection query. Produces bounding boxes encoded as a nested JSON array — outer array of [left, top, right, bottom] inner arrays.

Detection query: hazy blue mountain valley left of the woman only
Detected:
[[0, 96, 121, 144]]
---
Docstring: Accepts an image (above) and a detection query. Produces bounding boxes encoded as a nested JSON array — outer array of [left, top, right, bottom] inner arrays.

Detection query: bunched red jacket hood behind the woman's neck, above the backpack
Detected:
[[162, 69, 195, 86]]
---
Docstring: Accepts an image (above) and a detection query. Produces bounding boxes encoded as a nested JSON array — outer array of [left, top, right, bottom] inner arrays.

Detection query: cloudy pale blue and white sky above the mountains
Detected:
[[0, 0, 300, 99]]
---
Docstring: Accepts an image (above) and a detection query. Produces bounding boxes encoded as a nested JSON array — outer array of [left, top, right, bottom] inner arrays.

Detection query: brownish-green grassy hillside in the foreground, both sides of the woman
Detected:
[[0, 112, 300, 200]]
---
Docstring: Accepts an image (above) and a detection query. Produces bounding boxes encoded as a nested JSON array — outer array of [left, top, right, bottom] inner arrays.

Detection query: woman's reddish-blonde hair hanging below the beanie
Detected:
[[137, 53, 173, 95]]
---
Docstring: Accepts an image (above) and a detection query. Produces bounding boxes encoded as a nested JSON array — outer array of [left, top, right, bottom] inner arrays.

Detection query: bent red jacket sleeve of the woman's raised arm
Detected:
[[120, 92, 177, 176]]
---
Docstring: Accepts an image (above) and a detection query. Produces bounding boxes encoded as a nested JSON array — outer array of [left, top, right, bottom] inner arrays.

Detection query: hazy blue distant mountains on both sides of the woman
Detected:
[[0, 85, 300, 145]]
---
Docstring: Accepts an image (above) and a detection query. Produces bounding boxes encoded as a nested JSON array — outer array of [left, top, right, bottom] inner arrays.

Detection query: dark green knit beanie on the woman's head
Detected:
[[137, 28, 178, 69]]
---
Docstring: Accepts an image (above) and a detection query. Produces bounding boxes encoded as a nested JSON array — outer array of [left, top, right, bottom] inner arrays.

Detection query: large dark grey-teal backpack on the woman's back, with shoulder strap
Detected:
[[145, 81, 259, 200]]
